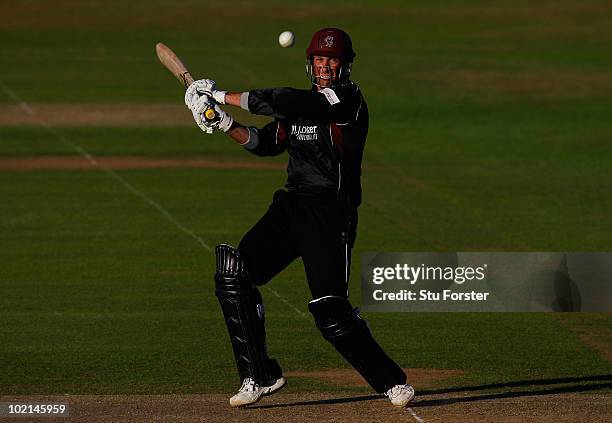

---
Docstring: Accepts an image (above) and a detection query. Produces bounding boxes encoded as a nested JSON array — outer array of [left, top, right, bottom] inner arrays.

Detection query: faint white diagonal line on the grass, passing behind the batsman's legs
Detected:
[[0, 81, 310, 322]]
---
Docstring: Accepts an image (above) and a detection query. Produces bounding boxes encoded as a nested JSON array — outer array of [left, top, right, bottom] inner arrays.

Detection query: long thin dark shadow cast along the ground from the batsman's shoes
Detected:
[[248, 375, 612, 408]]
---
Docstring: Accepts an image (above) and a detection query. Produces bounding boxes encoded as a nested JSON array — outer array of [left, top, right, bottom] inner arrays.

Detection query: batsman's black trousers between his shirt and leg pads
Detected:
[[238, 190, 357, 299]]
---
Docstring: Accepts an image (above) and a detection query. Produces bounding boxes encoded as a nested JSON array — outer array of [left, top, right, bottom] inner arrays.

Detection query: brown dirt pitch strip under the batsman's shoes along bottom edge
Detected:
[[0, 390, 612, 423]]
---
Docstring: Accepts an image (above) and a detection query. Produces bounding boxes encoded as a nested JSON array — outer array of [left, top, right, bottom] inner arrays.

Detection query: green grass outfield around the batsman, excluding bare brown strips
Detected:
[[0, 0, 612, 400]]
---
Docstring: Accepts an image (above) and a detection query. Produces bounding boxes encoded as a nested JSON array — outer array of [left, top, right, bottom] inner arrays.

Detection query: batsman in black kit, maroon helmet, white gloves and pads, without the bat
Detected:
[[185, 28, 414, 407]]
